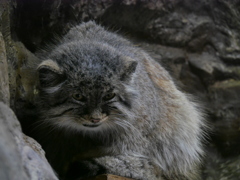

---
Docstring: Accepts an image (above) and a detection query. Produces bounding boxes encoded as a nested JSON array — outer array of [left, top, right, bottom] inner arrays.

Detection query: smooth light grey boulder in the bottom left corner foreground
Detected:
[[0, 102, 58, 180]]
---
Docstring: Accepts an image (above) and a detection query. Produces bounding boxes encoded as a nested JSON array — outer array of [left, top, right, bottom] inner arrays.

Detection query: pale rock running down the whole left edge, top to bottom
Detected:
[[0, 1, 58, 180]]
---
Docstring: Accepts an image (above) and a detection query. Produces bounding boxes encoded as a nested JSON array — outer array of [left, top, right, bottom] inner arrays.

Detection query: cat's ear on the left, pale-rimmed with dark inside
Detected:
[[37, 59, 66, 87]]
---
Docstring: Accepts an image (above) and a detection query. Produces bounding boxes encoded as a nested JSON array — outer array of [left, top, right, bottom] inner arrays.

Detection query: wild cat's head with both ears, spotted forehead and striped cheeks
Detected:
[[35, 43, 137, 132]]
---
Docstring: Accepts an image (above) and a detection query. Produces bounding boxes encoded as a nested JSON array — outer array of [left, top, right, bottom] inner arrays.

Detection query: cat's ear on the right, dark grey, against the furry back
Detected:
[[120, 57, 138, 81]]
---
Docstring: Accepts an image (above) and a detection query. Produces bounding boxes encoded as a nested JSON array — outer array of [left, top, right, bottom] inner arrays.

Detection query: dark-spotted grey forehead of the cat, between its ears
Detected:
[[50, 45, 122, 79]]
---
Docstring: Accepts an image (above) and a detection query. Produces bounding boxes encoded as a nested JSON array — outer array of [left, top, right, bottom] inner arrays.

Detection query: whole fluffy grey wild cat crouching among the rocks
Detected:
[[33, 22, 205, 180]]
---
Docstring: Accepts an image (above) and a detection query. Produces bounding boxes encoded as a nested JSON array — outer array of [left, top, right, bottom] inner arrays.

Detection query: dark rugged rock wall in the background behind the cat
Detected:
[[0, 0, 240, 180]]
